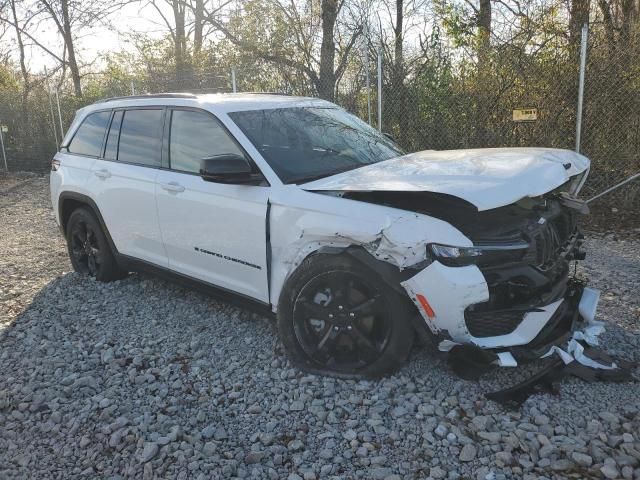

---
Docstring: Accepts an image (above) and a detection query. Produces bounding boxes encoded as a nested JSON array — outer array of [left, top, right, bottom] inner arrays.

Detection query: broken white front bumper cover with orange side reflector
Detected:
[[402, 261, 599, 365]]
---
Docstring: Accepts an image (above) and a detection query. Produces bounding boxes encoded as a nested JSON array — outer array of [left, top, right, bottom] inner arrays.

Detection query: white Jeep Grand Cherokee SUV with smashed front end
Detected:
[[51, 94, 597, 376]]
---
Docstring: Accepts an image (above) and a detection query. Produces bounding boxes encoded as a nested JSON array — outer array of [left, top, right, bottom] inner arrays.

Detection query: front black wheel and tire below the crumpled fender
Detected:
[[278, 254, 414, 378]]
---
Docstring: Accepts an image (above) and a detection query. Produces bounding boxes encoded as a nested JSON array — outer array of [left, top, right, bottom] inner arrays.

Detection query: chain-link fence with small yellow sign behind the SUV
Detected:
[[0, 24, 640, 212]]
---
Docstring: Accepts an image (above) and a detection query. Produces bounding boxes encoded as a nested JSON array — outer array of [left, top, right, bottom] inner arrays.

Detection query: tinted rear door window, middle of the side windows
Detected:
[[118, 110, 164, 167]]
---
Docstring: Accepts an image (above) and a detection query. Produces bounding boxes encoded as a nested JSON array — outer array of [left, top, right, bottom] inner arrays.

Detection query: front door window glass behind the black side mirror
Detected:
[[169, 110, 244, 173]]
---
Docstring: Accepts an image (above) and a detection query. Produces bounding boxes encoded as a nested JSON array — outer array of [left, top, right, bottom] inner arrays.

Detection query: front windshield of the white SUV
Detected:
[[229, 107, 403, 183]]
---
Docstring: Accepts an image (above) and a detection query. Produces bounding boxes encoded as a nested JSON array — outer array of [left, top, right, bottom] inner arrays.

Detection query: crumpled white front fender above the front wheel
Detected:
[[269, 186, 472, 311]]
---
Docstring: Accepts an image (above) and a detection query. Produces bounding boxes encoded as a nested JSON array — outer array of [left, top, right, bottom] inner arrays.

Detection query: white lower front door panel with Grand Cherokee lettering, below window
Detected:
[[156, 170, 269, 302]]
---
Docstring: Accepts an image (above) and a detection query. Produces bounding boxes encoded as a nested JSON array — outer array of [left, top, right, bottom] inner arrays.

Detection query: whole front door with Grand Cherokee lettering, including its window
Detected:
[[156, 108, 269, 302]]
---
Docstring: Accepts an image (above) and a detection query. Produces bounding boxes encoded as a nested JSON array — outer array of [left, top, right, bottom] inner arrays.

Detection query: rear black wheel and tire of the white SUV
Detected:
[[67, 207, 126, 282]]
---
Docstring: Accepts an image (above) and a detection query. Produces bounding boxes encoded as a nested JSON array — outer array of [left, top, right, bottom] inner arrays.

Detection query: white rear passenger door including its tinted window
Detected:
[[88, 107, 168, 267]]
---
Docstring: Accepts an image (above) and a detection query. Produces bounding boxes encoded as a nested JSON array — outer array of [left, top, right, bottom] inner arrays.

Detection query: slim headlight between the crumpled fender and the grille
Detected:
[[427, 242, 529, 267]]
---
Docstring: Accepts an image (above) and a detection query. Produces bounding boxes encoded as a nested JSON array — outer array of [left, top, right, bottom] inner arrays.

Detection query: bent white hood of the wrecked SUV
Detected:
[[300, 148, 590, 210]]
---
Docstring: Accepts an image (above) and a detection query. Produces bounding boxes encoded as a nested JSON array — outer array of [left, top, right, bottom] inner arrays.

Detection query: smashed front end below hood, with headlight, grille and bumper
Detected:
[[346, 189, 598, 366]]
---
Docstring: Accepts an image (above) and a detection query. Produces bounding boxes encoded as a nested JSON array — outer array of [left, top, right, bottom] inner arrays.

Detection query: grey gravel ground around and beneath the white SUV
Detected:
[[0, 173, 640, 479]]
